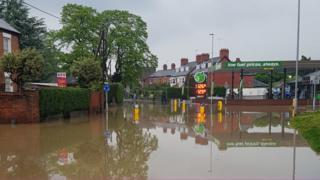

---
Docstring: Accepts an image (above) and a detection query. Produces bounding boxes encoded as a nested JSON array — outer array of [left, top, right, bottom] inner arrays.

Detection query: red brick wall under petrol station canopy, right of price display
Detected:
[[208, 72, 254, 88]]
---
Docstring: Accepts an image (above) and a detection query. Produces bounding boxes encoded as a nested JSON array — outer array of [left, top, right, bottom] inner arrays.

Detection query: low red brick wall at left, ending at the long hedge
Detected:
[[0, 91, 40, 123]]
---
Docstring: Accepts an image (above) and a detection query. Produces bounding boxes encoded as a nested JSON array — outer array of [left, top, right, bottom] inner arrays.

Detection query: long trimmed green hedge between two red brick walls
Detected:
[[39, 88, 90, 118]]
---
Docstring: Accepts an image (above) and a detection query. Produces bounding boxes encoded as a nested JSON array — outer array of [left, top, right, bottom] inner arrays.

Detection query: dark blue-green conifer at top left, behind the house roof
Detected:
[[0, 0, 46, 49]]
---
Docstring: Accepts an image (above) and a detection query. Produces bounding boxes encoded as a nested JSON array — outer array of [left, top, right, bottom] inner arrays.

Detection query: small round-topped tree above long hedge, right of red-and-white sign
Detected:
[[71, 58, 102, 88]]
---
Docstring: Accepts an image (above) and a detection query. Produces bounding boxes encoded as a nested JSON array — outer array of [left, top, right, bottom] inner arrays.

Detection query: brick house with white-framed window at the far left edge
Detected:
[[0, 19, 20, 91]]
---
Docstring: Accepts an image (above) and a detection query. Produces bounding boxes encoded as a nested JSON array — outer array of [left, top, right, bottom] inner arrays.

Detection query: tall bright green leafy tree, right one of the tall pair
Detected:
[[100, 10, 157, 84]]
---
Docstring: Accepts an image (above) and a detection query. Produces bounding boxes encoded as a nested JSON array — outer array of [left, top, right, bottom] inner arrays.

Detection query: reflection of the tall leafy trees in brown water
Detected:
[[50, 107, 158, 179]]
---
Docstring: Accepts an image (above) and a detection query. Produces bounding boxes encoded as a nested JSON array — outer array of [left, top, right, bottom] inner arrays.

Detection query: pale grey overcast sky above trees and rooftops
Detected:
[[25, 0, 320, 67]]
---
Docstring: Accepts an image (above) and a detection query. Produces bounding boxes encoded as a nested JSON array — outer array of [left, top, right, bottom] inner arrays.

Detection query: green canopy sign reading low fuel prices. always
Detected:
[[223, 61, 282, 69]]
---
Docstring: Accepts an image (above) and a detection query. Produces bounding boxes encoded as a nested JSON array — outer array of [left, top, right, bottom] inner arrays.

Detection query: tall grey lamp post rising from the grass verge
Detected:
[[293, 0, 301, 116]]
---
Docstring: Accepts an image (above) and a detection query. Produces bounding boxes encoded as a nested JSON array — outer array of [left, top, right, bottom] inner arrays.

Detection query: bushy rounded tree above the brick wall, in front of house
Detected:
[[0, 48, 44, 87]]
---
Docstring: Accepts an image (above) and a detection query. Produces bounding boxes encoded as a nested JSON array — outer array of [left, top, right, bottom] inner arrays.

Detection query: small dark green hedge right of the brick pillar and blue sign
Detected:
[[108, 83, 124, 104]]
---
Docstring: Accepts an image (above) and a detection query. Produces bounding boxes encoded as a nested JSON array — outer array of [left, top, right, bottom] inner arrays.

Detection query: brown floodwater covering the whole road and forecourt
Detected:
[[0, 104, 320, 179]]
